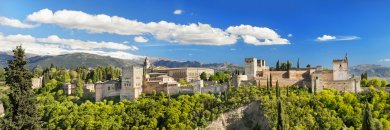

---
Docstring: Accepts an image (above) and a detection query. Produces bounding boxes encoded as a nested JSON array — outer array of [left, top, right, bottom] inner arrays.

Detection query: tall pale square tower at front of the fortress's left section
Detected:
[[120, 66, 143, 100]]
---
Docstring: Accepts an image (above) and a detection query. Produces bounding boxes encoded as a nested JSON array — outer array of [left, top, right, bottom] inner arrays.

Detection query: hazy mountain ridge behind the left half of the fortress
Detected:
[[0, 53, 241, 70]]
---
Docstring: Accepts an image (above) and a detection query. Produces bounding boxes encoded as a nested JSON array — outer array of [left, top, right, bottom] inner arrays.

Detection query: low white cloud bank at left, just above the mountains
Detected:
[[0, 34, 142, 59]]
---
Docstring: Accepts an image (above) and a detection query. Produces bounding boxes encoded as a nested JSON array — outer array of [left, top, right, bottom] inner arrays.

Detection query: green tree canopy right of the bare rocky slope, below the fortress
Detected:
[[261, 87, 390, 129]]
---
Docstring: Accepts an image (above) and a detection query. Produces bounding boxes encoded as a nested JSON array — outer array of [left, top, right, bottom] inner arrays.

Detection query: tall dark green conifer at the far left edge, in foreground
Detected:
[[3, 46, 40, 129]]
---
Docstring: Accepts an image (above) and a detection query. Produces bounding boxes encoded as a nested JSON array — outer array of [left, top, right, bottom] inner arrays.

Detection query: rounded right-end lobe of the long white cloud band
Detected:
[[226, 25, 290, 45]]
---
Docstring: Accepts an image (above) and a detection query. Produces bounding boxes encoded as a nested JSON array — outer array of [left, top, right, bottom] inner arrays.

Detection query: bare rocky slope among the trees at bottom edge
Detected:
[[205, 101, 269, 130]]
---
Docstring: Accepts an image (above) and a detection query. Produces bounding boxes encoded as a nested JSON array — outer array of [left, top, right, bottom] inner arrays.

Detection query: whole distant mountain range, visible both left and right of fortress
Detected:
[[0, 53, 390, 77]]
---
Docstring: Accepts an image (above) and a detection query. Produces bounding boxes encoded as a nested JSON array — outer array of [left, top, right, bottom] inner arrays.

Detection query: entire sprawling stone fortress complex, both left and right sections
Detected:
[[83, 55, 361, 102]]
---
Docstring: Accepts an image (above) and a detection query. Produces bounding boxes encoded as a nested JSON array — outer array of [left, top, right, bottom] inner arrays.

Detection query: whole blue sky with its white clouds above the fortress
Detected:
[[0, 0, 390, 67]]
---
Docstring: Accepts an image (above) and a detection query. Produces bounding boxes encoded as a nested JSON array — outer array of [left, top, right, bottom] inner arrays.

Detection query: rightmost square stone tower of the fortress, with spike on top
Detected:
[[333, 55, 349, 80]]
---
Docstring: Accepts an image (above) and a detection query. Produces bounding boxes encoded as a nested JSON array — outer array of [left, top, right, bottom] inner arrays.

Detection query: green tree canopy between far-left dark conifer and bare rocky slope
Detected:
[[38, 87, 261, 129]]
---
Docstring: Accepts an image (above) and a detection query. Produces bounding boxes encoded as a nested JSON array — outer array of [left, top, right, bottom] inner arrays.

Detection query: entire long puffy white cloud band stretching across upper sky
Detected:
[[27, 9, 289, 46]]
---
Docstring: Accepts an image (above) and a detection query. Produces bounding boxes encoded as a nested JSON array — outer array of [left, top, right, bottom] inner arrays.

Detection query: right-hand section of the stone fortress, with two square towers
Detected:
[[238, 55, 361, 93]]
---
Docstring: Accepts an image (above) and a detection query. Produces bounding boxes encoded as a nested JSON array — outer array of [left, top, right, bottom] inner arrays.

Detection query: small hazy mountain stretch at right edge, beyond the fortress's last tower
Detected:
[[349, 64, 390, 77]]
